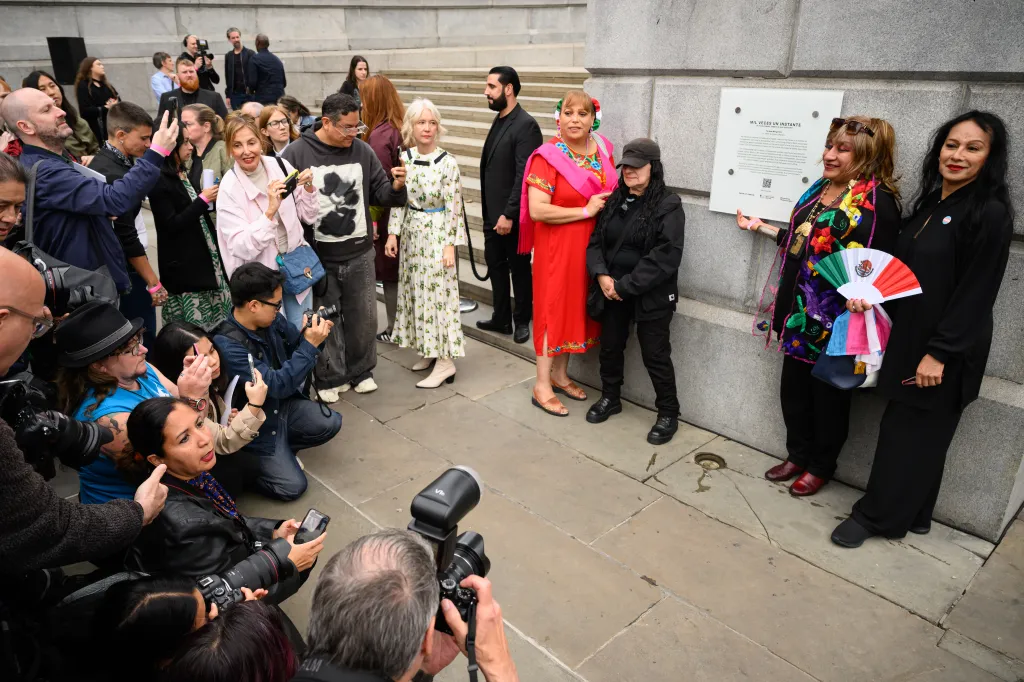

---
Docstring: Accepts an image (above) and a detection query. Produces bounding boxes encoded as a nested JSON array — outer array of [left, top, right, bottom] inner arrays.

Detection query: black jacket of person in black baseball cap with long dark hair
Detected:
[[587, 194, 686, 321]]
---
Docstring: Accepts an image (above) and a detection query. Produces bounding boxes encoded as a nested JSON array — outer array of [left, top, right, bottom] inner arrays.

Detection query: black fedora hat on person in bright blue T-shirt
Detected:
[[54, 301, 142, 368]]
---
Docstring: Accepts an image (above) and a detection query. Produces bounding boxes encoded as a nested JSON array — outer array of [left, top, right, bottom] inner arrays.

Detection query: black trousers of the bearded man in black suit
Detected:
[[483, 227, 534, 327]]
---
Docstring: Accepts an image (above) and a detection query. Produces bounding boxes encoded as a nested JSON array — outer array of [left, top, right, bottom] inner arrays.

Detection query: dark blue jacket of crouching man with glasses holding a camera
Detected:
[[213, 311, 319, 455]]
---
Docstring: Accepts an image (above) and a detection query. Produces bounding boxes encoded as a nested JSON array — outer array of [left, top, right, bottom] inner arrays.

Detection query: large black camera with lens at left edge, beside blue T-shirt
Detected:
[[0, 372, 114, 480]]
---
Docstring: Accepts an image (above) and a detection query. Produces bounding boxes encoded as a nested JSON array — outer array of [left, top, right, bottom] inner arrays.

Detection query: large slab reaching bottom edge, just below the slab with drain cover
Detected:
[[594, 498, 994, 682]]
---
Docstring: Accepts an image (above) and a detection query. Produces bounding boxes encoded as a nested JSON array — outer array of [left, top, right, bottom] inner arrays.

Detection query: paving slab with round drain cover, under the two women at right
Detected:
[[648, 438, 983, 624]]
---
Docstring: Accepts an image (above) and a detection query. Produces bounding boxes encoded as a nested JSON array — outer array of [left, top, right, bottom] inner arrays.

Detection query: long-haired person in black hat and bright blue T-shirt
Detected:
[[54, 301, 212, 504]]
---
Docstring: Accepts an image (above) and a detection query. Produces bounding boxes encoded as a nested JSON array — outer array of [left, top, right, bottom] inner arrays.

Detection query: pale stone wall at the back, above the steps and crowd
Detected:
[[0, 0, 587, 110]]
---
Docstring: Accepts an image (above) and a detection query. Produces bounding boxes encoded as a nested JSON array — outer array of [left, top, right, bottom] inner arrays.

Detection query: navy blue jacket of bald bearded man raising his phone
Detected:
[[20, 144, 164, 292]]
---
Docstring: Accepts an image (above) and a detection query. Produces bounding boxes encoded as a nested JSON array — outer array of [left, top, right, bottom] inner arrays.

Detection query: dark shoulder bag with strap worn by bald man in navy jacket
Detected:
[[11, 161, 118, 309]]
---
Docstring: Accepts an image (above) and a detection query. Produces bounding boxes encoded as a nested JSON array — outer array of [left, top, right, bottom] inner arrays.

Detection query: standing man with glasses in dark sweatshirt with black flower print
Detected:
[[282, 93, 407, 402]]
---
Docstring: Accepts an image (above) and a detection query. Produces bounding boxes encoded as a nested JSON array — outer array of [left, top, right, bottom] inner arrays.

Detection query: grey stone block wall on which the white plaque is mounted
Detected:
[[577, 0, 1024, 540]]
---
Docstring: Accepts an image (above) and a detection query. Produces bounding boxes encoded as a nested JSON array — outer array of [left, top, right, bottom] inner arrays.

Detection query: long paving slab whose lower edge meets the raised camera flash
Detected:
[[388, 395, 660, 543]]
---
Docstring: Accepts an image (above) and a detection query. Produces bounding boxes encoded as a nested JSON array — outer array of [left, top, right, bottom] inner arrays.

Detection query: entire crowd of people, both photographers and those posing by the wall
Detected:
[[0, 22, 1014, 682]]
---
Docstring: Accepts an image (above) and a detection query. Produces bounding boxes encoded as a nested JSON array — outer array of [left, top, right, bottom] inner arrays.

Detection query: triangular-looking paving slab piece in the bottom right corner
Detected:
[[943, 520, 1024, 660]]
